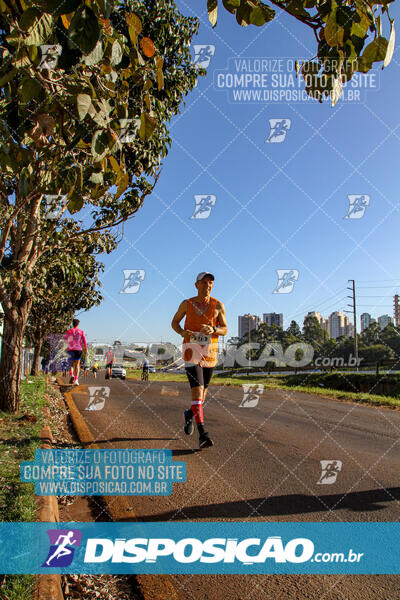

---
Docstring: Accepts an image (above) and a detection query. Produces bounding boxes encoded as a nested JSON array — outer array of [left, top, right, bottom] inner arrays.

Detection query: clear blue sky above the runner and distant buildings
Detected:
[[80, 0, 400, 343]]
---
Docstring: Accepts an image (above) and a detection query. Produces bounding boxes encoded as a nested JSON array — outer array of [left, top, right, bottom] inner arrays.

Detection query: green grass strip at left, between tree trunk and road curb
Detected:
[[0, 376, 46, 600]]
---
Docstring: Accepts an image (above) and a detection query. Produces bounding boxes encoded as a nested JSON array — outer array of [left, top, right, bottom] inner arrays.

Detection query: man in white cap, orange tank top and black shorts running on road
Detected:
[[171, 272, 228, 448]]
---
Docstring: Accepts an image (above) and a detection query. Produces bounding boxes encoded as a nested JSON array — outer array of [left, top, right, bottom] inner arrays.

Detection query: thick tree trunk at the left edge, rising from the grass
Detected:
[[0, 300, 30, 412]]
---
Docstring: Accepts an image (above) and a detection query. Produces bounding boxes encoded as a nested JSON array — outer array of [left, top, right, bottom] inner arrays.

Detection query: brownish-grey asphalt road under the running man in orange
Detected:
[[66, 373, 400, 600]]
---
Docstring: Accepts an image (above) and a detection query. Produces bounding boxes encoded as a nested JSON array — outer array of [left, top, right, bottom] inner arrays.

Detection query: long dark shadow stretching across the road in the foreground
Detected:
[[127, 487, 400, 521]]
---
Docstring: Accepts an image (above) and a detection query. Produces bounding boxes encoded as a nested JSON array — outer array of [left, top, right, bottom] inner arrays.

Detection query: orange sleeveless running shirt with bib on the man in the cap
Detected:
[[182, 298, 218, 367]]
